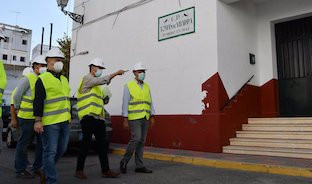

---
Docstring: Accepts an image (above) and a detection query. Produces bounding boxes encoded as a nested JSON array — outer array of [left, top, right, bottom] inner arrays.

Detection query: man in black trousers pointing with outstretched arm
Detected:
[[75, 58, 126, 179]]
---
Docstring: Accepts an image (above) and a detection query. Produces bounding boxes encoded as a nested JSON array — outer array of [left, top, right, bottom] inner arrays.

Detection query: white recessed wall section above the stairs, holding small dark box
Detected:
[[217, 0, 259, 97]]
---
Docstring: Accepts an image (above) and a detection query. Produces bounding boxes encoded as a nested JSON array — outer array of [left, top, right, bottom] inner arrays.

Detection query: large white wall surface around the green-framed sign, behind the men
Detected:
[[70, 0, 218, 115]]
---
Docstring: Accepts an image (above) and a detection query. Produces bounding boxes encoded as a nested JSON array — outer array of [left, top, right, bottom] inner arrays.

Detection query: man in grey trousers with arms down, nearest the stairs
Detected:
[[120, 63, 155, 173]]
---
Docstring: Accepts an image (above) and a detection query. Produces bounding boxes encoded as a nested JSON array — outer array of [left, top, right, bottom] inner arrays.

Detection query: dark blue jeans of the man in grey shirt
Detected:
[[15, 118, 42, 173]]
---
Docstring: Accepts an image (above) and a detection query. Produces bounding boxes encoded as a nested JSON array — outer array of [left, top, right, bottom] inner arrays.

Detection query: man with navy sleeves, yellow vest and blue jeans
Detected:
[[34, 48, 71, 184]]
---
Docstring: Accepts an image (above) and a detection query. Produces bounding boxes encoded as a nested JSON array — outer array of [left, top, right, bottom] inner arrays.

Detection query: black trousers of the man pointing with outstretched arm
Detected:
[[76, 116, 109, 172]]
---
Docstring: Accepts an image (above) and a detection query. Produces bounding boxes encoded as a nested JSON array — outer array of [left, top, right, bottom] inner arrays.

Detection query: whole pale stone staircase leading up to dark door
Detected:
[[223, 118, 312, 159]]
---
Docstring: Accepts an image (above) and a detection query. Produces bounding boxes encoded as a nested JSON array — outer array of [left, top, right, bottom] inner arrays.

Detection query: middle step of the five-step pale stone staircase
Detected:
[[236, 131, 312, 141]]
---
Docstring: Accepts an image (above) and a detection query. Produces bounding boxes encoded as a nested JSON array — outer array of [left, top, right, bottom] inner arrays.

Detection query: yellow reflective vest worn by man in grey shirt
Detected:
[[17, 73, 38, 119]]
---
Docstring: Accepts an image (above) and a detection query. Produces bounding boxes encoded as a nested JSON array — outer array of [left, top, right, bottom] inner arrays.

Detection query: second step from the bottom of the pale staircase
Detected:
[[230, 138, 312, 149]]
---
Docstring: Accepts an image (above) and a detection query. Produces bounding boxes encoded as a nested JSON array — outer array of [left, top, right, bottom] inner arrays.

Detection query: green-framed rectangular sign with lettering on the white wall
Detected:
[[158, 7, 195, 41]]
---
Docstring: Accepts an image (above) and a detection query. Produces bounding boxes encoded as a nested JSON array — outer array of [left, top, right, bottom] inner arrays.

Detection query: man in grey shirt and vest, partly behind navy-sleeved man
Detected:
[[12, 56, 47, 178]]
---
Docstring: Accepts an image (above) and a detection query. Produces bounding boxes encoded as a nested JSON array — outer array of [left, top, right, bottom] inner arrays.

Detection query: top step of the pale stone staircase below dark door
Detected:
[[248, 117, 312, 124]]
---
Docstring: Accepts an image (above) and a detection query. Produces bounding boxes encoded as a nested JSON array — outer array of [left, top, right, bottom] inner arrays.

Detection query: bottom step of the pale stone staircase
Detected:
[[223, 146, 312, 159]]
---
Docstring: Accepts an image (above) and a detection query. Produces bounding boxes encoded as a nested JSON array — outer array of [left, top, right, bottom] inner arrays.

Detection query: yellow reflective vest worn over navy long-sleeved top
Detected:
[[39, 72, 71, 126]]
